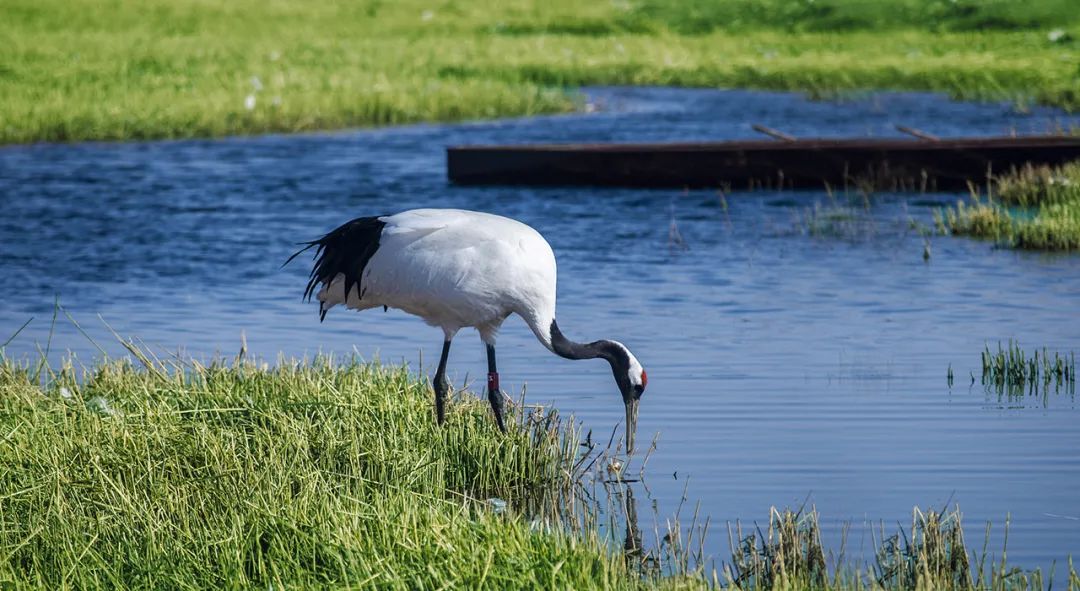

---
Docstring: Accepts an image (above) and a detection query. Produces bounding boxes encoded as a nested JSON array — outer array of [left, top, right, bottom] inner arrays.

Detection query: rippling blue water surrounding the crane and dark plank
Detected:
[[0, 89, 1080, 567]]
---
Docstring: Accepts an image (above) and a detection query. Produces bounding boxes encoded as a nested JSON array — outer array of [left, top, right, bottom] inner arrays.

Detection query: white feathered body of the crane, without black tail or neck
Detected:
[[318, 210, 556, 349]]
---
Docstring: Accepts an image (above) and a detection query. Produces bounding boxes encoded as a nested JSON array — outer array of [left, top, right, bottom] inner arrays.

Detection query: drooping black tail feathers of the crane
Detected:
[[282, 216, 386, 321]]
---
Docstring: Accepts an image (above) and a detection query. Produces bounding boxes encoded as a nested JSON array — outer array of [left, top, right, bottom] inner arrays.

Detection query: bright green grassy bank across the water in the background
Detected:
[[0, 0, 1080, 143]]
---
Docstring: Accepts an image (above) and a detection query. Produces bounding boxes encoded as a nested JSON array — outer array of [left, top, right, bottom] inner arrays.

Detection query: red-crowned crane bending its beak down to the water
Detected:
[[286, 210, 648, 453]]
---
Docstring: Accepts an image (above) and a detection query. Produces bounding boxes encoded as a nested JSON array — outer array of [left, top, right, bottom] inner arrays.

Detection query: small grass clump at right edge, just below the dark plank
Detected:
[[936, 162, 1080, 252]]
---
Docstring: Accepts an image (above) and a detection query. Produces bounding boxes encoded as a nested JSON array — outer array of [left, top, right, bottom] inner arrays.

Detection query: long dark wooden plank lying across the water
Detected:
[[447, 136, 1080, 189]]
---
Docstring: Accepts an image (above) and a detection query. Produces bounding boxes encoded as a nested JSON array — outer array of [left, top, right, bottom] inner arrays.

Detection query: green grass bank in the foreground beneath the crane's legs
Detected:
[[0, 361, 673, 589]]
